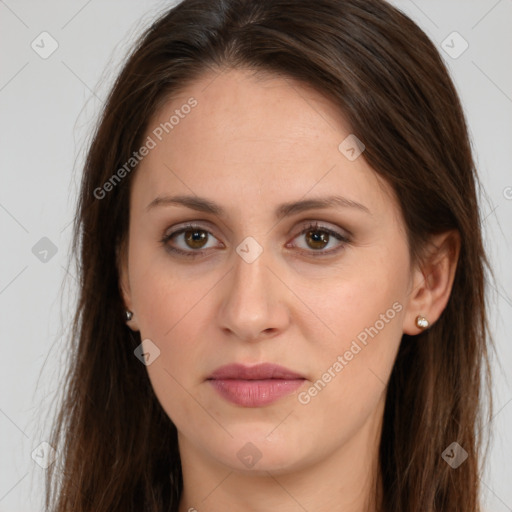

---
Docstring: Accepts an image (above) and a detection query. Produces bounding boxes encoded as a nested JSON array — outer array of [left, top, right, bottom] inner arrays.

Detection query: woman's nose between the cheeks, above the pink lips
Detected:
[[217, 245, 290, 341]]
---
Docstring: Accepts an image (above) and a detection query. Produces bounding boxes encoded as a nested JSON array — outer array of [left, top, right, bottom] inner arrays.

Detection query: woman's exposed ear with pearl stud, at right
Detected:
[[404, 230, 460, 335]]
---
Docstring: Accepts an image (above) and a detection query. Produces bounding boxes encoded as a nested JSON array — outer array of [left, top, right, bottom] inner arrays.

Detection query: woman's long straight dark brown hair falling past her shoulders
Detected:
[[46, 0, 490, 512]]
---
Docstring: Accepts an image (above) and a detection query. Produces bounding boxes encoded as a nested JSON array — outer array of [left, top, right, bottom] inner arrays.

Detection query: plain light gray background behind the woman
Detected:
[[0, 0, 512, 512]]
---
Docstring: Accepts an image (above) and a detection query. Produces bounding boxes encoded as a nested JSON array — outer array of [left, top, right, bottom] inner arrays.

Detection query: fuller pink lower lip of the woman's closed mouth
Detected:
[[209, 379, 304, 407]]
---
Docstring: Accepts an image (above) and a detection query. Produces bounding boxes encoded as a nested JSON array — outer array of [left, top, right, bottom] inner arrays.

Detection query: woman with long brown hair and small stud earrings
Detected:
[[47, 0, 494, 512]]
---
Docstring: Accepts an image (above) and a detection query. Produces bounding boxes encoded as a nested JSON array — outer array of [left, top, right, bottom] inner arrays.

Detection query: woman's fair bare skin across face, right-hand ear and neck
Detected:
[[120, 70, 458, 512]]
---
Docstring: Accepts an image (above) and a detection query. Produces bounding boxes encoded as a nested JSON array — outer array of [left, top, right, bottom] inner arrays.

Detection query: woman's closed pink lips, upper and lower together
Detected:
[[207, 363, 306, 407]]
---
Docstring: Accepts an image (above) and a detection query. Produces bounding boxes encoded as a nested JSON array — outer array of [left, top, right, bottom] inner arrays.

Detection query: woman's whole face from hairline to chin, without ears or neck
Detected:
[[122, 70, 412, 472]]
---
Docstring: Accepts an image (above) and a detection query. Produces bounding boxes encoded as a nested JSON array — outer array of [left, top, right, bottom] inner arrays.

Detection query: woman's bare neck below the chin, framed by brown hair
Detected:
[[178, 398, 383, 512]]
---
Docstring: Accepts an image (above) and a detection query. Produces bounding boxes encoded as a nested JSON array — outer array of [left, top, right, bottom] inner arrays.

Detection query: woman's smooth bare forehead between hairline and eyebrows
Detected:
[[133, 66, 396, 222]]
